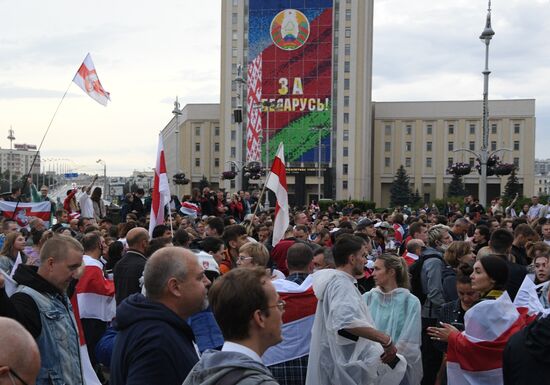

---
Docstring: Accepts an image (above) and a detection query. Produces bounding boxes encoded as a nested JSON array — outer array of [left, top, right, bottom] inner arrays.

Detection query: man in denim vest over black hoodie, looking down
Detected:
[[0, 235, 84, 384]]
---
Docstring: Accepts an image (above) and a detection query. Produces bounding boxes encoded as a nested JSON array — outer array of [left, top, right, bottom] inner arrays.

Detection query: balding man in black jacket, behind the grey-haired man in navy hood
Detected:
[[113, 227, 149, 303]]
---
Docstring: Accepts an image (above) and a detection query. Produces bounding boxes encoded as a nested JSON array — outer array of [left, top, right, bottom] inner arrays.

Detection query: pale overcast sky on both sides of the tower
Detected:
[[0, 0, 550, 175]]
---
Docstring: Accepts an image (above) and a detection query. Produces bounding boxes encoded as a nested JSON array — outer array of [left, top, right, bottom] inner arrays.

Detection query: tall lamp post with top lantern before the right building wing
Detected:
[[478, 0, 495, 207]]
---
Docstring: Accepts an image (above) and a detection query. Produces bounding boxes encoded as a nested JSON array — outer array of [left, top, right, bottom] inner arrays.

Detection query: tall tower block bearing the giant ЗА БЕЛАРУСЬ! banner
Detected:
[[220, 0, 373, 205]]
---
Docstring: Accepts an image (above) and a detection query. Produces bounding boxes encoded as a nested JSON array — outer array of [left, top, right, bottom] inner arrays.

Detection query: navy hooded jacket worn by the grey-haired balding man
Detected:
[[110, 294, 199, 385]]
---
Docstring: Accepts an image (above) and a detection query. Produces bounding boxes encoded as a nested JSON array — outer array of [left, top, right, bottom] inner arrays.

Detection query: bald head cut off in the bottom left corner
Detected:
[[0, 317, 40, 385]]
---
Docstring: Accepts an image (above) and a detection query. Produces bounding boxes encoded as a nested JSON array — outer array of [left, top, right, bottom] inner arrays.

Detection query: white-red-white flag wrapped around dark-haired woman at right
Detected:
[[447, 293, 534, 385]]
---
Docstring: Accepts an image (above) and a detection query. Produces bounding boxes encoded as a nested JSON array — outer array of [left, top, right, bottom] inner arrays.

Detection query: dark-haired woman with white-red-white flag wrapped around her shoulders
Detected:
[[428, 255, 533, 385]]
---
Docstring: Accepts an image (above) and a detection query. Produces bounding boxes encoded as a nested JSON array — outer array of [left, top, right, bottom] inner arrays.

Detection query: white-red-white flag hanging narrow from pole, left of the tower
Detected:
[[149, 136, 170, 235]]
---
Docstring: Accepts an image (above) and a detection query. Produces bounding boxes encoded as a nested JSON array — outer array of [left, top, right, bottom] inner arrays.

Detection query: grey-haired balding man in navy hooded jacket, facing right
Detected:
[[110, 247, 210, 385]]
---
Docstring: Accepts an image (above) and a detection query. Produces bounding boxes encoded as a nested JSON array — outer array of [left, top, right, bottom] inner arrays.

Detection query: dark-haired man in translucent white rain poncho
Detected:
[[306, 234, 406, 385]]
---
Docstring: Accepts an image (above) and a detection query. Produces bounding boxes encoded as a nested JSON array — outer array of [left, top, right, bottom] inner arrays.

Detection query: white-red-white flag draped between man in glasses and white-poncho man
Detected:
[[262, 275, 317, 366]]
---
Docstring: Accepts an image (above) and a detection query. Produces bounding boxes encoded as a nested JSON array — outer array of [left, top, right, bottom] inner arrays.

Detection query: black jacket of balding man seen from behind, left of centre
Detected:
[[113, 250, 147, 303]]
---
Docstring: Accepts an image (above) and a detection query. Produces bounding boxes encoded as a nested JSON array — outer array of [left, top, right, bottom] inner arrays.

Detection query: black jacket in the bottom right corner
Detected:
[[502, 317, 550, 385]]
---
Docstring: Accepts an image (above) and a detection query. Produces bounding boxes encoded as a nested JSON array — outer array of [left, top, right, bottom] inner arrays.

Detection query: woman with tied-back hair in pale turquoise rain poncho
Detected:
[[363, 254, 423, 385]]
